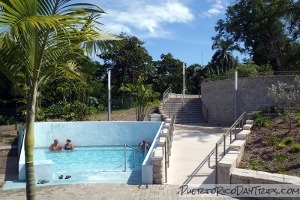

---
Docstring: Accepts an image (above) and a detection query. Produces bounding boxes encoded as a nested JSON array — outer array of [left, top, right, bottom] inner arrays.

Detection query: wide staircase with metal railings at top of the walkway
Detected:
[[162, 95, 206, 124]]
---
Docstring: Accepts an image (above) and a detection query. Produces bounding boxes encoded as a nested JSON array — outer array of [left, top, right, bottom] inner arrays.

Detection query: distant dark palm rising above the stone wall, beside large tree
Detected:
[[212, 39, 236, 73]]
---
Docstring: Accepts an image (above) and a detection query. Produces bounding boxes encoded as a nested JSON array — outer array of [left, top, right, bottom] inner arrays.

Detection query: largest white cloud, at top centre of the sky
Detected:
[[99, 0, 194, 38]]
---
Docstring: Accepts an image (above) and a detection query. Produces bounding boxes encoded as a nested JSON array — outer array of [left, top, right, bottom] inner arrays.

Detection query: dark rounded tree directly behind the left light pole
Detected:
[[99, 33, 153, 109]]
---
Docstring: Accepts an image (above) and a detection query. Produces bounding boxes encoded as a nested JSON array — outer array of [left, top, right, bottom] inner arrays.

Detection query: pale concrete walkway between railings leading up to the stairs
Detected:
[[167, 124, 228, 186]]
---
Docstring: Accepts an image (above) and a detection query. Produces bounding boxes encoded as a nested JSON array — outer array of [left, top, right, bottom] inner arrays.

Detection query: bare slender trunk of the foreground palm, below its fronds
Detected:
[[25, 83, 37, 200]]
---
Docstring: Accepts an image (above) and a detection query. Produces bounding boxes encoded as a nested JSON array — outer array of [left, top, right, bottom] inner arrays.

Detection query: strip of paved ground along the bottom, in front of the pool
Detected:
[[0, 183, 238, 200]]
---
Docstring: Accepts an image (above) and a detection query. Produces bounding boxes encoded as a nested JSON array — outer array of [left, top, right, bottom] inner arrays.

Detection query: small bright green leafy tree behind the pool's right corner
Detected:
[[120, 77, 160, 121]]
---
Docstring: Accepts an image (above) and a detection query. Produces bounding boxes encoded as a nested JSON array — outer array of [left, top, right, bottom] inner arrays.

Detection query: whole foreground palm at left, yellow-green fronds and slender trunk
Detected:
[[0, 0, 116, 199]]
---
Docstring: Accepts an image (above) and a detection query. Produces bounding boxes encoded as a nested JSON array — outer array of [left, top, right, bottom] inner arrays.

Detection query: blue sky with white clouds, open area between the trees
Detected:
[[90, 0, 241, 66]]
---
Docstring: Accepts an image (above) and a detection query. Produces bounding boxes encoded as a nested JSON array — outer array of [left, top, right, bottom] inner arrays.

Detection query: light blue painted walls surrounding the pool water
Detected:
[[19, 121, 163, 184]]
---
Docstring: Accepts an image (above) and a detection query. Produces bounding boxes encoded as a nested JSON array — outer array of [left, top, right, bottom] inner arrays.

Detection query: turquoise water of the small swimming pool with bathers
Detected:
[[35, 146, 144, 184]]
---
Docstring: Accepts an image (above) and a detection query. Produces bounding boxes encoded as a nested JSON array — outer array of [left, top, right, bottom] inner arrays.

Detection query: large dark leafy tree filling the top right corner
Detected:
[[214, 0, 300, 70]]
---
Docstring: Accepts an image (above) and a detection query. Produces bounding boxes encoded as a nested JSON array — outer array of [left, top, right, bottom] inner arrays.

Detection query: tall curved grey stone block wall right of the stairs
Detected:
[[201, 76, 295, 125]]
